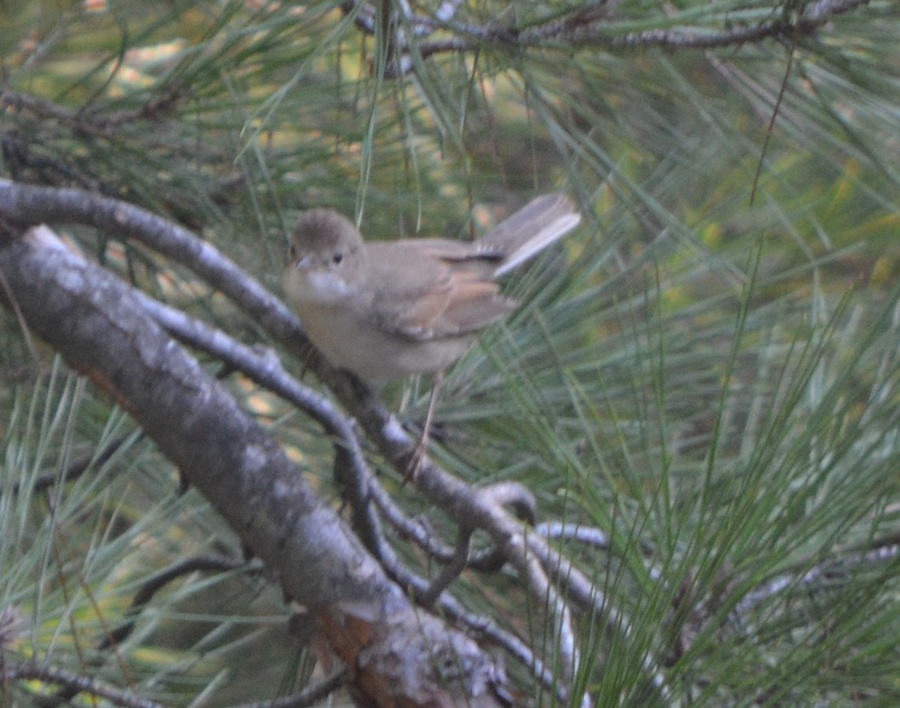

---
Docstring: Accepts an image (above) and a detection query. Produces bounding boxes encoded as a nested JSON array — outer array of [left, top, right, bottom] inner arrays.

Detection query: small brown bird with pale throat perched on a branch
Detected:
[[283, 194, 581, 472]]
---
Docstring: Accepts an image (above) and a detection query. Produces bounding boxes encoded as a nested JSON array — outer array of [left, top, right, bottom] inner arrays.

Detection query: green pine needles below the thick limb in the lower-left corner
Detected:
[[0, 362, 296, 705]]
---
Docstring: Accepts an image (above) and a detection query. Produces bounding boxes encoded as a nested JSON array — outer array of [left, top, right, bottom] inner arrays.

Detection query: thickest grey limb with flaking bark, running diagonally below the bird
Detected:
[[0, 227, 506, 705]]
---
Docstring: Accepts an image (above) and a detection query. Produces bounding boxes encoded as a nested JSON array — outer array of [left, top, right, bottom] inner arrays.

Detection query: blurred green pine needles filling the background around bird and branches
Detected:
[[0, 0, 900, 706]]
